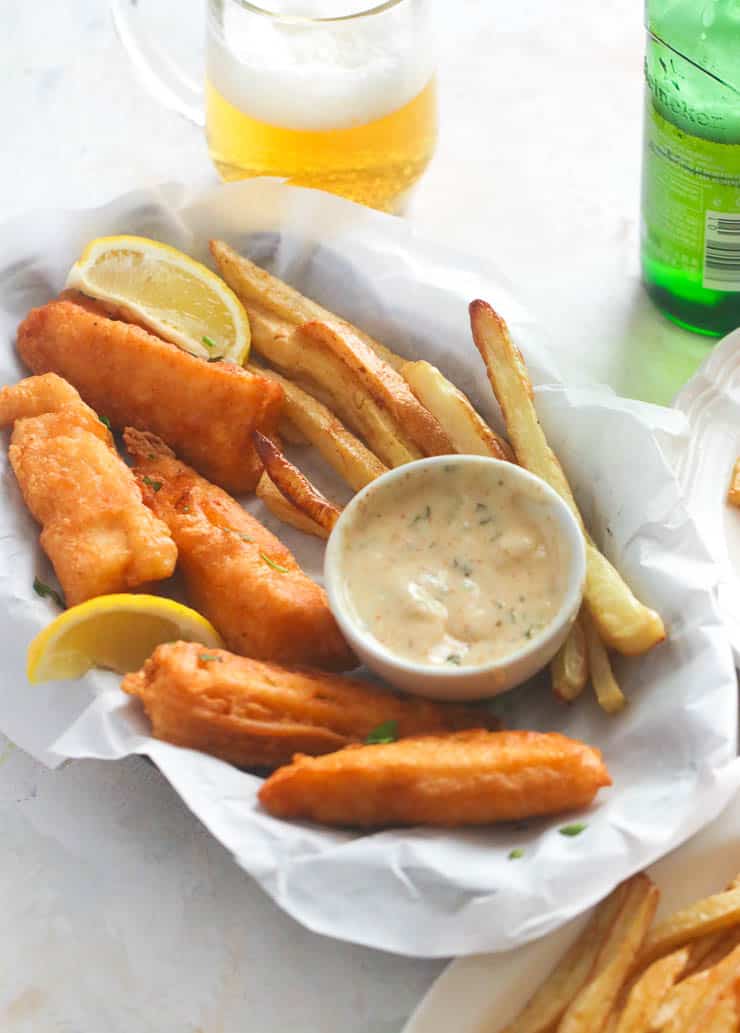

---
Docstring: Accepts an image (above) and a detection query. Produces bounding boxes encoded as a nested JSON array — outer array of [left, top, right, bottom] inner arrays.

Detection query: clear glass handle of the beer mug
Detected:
[[111, 0, 206, 126]]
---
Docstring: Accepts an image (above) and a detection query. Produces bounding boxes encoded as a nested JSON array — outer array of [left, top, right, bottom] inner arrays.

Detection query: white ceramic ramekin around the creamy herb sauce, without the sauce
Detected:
[[323, 456, 586, 700]]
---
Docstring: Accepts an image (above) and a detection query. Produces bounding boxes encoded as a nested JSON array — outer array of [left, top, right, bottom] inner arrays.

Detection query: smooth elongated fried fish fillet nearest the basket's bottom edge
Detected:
[[259, 730, 612, 827]]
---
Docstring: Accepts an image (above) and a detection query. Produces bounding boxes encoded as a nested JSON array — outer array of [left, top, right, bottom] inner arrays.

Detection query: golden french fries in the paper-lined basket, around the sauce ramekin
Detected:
[[211, 241, 666, 713]]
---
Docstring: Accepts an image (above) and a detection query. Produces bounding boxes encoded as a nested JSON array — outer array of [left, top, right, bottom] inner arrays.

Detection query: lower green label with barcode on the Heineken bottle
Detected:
[[643, 100, 740, 291]]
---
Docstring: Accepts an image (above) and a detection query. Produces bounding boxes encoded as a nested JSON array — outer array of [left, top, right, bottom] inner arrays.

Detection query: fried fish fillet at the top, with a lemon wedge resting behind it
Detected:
[[18, 292, 282, 494]]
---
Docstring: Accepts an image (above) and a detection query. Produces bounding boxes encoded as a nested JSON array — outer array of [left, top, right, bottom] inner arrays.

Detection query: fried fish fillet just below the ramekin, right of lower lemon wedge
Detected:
[[121, 643, 500, 768]]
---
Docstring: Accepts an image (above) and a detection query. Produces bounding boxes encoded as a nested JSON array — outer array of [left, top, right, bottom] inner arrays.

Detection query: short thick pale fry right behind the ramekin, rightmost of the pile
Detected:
[[401, 359, 515, 463]]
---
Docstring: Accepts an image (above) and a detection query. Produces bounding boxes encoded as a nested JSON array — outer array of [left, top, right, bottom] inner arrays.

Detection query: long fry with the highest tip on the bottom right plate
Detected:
[[557, 875, 659, 1033]]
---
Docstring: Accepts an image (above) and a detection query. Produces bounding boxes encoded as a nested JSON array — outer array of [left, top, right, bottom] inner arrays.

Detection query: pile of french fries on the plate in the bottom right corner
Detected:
[[500, 874, 740, 1033]]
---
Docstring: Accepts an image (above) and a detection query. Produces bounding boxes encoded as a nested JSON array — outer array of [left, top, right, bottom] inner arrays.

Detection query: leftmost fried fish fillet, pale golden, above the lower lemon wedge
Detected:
[[0, 373, 177, 605]]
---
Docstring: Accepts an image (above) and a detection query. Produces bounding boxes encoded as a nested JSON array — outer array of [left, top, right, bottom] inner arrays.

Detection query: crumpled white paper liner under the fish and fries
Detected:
[[0, 181, 740, 957]]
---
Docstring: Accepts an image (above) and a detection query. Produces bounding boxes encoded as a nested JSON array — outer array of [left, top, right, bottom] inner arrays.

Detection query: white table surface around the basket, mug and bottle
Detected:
[[0, 0, 709, 1033]]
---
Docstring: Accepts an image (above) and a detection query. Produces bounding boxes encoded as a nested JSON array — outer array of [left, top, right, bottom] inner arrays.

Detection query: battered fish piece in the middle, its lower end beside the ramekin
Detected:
[[124, 428, 358, 670]]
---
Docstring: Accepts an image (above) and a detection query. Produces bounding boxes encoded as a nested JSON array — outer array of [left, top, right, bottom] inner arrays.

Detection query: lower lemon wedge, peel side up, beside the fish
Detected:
[[26, 593, 223, 684]]
